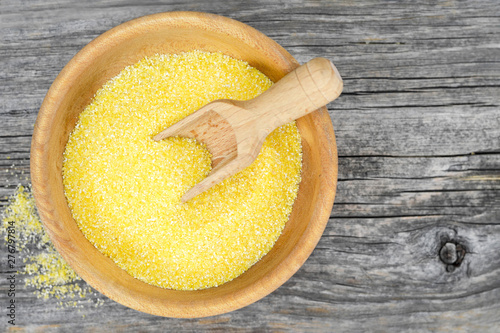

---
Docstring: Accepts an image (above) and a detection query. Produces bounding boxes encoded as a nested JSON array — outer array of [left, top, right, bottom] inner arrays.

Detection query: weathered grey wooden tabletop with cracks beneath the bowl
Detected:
[[0, 0, 500, 332]]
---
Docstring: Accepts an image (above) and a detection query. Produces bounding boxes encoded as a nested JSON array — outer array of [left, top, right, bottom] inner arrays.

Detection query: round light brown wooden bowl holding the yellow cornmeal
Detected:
[[31, 12, 337, 318]]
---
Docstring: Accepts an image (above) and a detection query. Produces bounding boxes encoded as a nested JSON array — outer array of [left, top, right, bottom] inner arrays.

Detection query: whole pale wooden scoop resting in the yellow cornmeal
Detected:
[[153, 58, 343, 202]]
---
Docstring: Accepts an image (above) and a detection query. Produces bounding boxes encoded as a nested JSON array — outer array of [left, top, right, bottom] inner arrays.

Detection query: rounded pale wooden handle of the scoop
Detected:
[[244, 58, 343, 135]]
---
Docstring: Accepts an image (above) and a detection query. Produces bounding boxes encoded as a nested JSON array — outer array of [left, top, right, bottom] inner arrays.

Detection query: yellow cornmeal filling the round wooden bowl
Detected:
[[63, 51, 302, 290]]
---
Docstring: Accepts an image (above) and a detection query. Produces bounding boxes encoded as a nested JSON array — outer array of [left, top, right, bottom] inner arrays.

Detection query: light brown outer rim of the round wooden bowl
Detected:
[[30, 11, 337, 318]]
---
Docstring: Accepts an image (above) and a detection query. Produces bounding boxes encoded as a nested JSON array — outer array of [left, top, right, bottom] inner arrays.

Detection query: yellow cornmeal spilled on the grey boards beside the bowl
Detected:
[[0, 185, 104, 308]]
